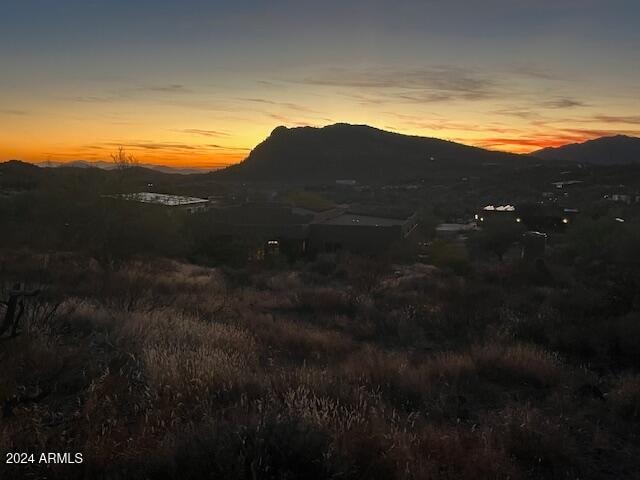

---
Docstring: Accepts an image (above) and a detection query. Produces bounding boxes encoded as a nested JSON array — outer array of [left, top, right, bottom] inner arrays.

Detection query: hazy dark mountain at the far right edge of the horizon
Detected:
[[531, 135, 640, 165]]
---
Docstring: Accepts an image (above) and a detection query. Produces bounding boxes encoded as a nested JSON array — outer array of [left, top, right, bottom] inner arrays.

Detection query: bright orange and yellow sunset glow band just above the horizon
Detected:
[[0, 103, 640, 170]]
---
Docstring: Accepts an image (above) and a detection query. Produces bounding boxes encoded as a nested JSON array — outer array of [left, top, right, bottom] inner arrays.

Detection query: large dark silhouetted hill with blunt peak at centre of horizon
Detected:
[[214, 124, 532, 182]]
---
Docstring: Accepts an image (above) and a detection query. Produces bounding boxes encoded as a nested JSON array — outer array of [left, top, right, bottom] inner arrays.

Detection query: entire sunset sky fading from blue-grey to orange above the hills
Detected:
[[0, 0, 640, 168]]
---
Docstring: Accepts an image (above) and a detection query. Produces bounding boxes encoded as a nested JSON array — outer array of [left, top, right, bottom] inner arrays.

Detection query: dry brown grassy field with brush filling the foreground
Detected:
[[0, 251, 640, 479]]
